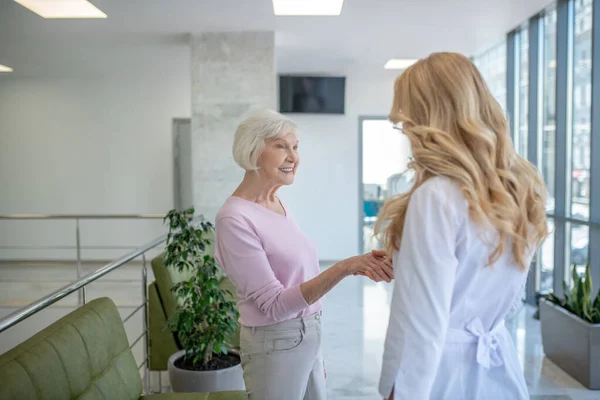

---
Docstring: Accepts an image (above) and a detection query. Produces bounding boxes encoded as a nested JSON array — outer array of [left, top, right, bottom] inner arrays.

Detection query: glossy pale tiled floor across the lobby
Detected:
[[0, 264, 600, 400]]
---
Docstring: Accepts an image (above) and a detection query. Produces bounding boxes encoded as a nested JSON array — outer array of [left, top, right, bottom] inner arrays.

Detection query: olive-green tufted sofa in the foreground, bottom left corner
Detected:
[[0, 297, 246, 400]]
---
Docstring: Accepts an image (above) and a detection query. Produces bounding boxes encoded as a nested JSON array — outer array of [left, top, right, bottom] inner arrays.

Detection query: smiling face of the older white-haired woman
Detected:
[[258, 133, 300, 186]]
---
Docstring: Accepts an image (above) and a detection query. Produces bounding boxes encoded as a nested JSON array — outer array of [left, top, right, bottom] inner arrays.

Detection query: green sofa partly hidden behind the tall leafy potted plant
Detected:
[[148, 238, 240, 371]]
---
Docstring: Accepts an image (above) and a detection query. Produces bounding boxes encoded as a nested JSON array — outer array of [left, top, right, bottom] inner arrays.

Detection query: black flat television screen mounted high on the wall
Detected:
[[279, 75, 346, 114]]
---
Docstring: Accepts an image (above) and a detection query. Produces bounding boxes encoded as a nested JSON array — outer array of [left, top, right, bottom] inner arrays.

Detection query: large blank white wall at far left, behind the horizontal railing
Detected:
[[0, 63, 190, 259]]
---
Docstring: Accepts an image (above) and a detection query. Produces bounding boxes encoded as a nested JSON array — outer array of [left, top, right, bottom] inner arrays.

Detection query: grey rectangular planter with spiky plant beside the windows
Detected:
[[540, 264, 600, 390]]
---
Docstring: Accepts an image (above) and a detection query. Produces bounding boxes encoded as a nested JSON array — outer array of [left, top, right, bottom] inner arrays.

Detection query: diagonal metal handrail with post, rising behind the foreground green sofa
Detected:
[[0, 230, 167, 393]]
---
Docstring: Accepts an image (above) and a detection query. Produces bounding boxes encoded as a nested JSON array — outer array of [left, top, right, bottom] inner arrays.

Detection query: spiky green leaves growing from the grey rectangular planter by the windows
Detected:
[[548, 264, 600, 324]]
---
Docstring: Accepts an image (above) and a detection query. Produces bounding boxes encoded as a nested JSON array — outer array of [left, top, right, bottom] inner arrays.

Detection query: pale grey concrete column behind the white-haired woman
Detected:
[[191, 32, 276, 221]]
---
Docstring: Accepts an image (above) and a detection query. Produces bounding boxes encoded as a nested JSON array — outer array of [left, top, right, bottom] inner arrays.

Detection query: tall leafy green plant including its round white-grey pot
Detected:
[[165, 208, 245, 392]]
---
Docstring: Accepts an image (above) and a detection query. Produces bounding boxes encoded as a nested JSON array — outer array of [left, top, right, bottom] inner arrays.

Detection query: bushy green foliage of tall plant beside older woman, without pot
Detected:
[[165, 208, 240, 371]]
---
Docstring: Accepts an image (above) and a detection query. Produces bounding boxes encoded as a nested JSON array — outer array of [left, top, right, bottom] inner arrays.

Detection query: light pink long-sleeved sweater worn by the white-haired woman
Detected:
[[215, 196, 321, 327]]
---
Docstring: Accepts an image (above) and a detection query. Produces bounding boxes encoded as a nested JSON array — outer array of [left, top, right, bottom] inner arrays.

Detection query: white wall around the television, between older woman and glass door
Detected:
[[281, 68, 396, 260]]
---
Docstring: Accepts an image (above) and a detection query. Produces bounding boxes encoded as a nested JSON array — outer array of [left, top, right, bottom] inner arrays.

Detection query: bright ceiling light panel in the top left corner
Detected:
[[15, 0, 106, 18]]
